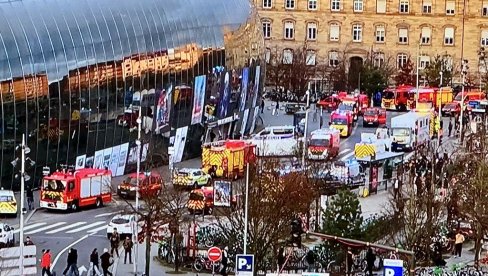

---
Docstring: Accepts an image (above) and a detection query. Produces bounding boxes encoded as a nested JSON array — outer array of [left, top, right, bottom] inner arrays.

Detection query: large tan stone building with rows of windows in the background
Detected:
[[254, 0, 488, 86]]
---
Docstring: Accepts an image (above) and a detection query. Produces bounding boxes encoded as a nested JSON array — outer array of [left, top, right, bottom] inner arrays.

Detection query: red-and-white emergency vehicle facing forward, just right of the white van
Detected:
[[307, 128, 341, 160]]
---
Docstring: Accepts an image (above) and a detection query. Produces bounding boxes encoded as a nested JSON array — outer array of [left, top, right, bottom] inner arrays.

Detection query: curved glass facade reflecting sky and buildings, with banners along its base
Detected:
[[0, 0, 264, 189]]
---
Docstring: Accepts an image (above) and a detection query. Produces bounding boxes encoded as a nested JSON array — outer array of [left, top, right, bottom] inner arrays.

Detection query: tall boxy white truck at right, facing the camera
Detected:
[[390, 111, 433, 151]]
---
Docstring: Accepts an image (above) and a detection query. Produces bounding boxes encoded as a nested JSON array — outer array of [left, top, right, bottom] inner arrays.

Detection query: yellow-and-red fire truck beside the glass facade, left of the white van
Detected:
[[202, 140, 256, 179]]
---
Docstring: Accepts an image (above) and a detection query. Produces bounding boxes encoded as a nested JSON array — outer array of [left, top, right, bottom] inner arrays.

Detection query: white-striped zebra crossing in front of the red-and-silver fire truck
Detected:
[[14, 220, 107, 235]]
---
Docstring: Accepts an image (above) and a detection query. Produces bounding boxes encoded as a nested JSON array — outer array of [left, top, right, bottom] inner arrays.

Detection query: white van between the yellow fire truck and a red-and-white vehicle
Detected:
[[250, 126, 298, 156]]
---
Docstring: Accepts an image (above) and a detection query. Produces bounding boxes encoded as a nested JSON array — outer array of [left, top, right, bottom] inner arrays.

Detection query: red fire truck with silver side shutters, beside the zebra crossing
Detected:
[[40, 168, 112, 212]]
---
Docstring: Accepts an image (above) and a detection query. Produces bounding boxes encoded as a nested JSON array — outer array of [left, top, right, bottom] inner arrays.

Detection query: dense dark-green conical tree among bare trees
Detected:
[[322, 190, 363, 239]]
